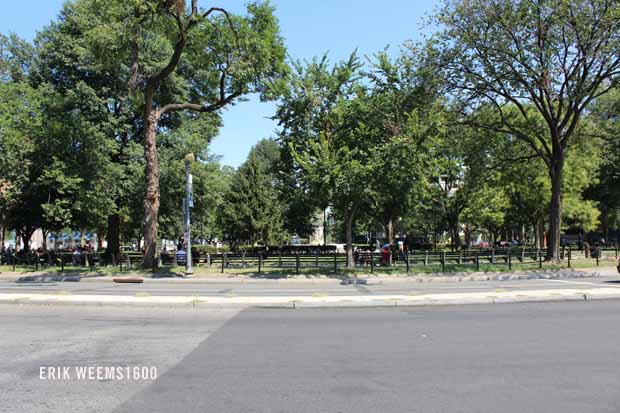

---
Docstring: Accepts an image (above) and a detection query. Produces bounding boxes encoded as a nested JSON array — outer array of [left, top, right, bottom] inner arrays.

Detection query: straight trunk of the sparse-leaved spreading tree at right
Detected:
[[547, 155, 564, 264]]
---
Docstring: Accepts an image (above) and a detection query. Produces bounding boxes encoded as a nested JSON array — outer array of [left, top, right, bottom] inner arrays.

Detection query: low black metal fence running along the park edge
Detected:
[[0, 246, 620, 273]]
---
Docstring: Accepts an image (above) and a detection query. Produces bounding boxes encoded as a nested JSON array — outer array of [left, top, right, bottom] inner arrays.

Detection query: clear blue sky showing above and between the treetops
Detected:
[[0, 0, 439, 166]]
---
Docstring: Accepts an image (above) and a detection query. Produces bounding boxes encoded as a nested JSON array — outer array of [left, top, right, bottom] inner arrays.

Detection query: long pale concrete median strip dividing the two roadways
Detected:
[[0, 286, 620, 308]]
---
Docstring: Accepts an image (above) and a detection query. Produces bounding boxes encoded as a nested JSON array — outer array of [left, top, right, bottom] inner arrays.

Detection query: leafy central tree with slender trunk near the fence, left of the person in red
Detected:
[[277, 53, 380, 266]]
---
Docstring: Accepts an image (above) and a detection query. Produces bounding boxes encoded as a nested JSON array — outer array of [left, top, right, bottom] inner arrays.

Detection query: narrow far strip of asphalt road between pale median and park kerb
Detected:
[[0, 276, 620, 297]]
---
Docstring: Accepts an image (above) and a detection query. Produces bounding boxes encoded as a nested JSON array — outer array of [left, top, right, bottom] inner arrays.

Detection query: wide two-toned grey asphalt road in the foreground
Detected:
[[0, 301, 620, 413]]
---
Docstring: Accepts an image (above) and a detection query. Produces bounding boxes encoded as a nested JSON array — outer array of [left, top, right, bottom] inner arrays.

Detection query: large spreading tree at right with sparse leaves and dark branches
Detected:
[[436, 0, 620, 262]]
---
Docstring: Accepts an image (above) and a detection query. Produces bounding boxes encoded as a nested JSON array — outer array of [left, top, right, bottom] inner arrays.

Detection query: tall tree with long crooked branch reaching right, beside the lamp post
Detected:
[[128, 0, 286, 268]]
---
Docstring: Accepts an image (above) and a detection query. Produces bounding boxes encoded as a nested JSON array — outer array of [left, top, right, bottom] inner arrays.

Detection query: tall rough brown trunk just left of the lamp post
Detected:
[[142, 108, 159, 269]]
